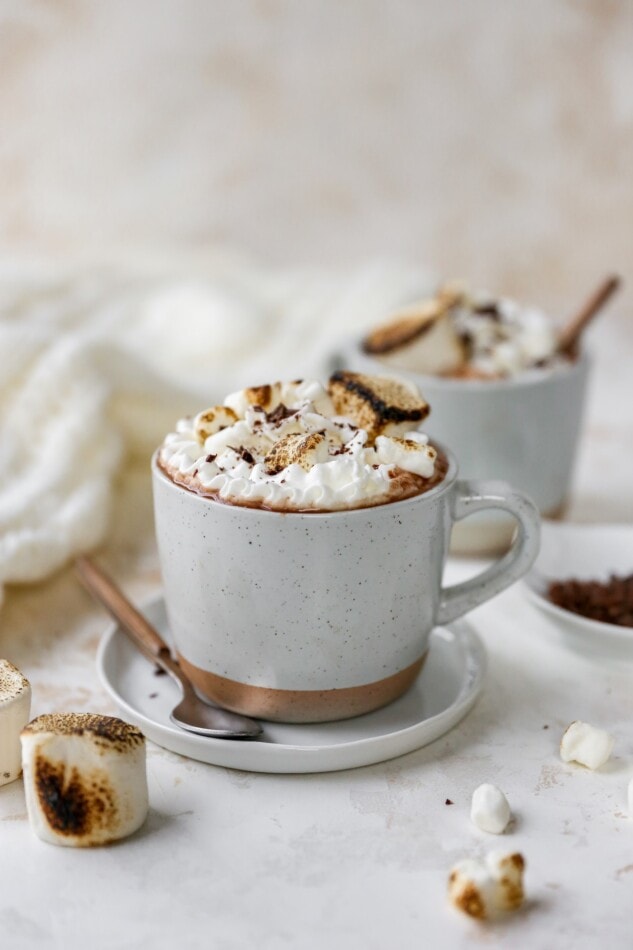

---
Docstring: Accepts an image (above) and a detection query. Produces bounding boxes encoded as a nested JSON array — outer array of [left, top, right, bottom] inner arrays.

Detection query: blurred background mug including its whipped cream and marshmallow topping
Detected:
[[335, 286, 590, 554]]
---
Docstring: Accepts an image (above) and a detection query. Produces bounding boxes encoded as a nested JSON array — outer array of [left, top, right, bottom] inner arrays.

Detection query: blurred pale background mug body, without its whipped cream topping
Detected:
[[334, 340, 590, 554]]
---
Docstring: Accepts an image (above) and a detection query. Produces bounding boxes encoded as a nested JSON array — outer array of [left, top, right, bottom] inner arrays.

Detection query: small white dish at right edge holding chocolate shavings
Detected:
[[522, 522, 633, 660]]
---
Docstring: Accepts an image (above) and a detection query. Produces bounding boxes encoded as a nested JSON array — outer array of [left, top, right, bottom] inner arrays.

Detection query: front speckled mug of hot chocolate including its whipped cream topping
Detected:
[[152, 371, 539, 722]]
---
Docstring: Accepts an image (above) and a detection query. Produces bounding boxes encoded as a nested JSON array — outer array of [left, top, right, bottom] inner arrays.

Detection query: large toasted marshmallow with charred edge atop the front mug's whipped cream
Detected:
[[328, 370, 430, 442]]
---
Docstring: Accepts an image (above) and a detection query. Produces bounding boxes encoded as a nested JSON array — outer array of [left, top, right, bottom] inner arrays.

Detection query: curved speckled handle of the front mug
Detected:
[[436, 479, 541, 624]]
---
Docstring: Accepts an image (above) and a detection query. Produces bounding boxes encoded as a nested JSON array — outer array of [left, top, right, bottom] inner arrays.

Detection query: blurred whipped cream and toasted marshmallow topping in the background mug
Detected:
[[364, 284, 564, 379]]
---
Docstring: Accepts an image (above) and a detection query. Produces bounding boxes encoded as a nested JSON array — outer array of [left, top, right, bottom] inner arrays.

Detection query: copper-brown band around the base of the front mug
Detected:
[[178, 651, 428, 722]]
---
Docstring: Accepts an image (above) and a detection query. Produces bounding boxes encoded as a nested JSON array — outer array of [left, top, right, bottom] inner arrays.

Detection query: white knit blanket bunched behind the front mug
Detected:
[[0, 260, 429, 600]]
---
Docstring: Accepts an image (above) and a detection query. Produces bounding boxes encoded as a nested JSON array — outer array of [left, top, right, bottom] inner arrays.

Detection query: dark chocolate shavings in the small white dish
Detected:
[[547, 574, 633, 627]]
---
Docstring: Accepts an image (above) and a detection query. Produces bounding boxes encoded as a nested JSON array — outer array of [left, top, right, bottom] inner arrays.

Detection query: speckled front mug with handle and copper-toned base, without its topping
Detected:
[[152, 449, 539, 722]]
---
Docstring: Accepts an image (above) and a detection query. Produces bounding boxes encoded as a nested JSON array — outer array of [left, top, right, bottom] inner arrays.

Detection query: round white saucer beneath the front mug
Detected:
[[97, 598, 486, 773]]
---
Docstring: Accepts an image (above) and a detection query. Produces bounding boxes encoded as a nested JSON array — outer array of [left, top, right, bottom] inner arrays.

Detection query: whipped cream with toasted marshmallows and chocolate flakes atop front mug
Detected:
[[158, 371, 439, 511]]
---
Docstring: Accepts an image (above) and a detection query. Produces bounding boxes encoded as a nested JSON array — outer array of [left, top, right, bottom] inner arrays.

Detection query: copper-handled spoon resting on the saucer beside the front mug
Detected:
[[75, 555, 262, 739]]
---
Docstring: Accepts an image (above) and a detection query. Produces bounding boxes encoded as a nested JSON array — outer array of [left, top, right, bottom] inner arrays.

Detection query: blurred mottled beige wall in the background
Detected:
[[0, 0, 633, 310]]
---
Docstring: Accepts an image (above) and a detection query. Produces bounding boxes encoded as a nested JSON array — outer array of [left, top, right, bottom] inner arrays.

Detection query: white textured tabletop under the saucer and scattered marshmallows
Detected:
[[0, 464, 633, 950]]
